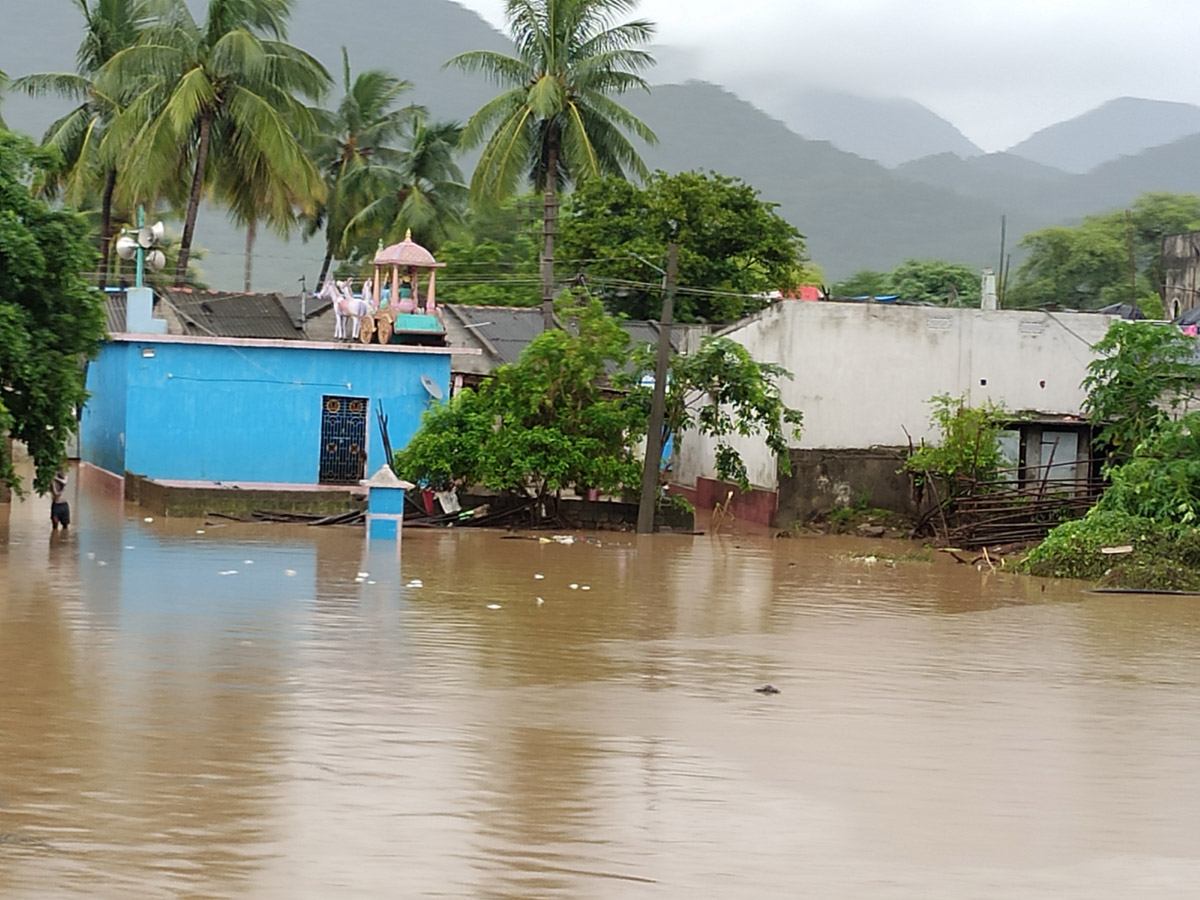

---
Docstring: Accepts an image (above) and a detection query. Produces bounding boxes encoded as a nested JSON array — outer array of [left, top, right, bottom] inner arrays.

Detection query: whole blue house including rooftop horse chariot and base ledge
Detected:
[[79, 236, 478, 515]]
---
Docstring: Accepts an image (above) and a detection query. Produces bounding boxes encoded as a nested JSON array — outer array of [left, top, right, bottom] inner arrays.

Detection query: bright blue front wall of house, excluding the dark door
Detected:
[[89, 341, 450, 484]]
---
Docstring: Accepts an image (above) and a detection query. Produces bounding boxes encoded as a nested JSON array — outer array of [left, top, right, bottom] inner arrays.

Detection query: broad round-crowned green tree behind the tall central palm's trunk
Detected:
[[562, 172, 805, 322]]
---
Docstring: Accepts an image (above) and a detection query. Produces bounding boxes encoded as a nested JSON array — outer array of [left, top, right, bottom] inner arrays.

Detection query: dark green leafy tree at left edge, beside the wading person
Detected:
[[0, 132, 104, 493]]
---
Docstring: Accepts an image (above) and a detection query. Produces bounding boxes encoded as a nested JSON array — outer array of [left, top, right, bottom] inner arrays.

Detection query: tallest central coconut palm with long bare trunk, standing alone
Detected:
[[446, 0, 655, 328]]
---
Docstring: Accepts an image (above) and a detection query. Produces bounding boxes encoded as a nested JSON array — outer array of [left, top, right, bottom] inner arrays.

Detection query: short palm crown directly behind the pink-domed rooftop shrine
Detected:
[[346, 113, 467, 254]]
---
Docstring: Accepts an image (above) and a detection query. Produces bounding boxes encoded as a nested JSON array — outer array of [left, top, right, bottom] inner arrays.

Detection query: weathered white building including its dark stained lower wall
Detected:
[[673, 301, 1115, 524]]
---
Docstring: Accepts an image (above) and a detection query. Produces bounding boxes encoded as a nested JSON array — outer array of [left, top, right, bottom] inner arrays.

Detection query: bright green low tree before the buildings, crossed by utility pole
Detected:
[[396, 298, 800, 506]]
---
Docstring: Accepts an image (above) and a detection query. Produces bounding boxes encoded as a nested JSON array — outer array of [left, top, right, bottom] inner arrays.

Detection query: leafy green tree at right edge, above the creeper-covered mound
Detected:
[[1082, 322, 1200, 458]]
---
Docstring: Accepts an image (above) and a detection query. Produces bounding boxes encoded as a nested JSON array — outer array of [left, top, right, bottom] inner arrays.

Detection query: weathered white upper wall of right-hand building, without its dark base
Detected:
[[676, 301, 1112, 490]]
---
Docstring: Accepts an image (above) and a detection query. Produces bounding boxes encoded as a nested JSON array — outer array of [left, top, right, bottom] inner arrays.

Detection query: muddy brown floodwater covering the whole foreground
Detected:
[[0, 468, 1200, 900]]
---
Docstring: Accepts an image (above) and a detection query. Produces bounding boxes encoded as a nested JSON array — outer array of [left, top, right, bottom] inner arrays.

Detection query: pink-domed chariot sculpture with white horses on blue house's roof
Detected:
[[318, 230, 445, 344]]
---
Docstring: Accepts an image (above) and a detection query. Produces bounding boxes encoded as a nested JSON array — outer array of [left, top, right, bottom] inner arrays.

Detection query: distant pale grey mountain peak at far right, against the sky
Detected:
[[1008, 97, 1200, 174]]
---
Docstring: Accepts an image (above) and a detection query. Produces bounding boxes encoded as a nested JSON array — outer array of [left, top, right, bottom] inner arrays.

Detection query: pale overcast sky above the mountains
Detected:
[[458, 0, 1200, 150]]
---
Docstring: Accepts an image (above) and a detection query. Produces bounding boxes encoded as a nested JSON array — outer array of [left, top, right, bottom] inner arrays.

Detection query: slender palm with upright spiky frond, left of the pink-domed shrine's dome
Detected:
[[305, 47, 420, 286]]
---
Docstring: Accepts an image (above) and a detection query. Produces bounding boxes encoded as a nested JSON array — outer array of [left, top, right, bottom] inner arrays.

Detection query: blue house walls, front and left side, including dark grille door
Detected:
[[80, 316, 462, 486]]
